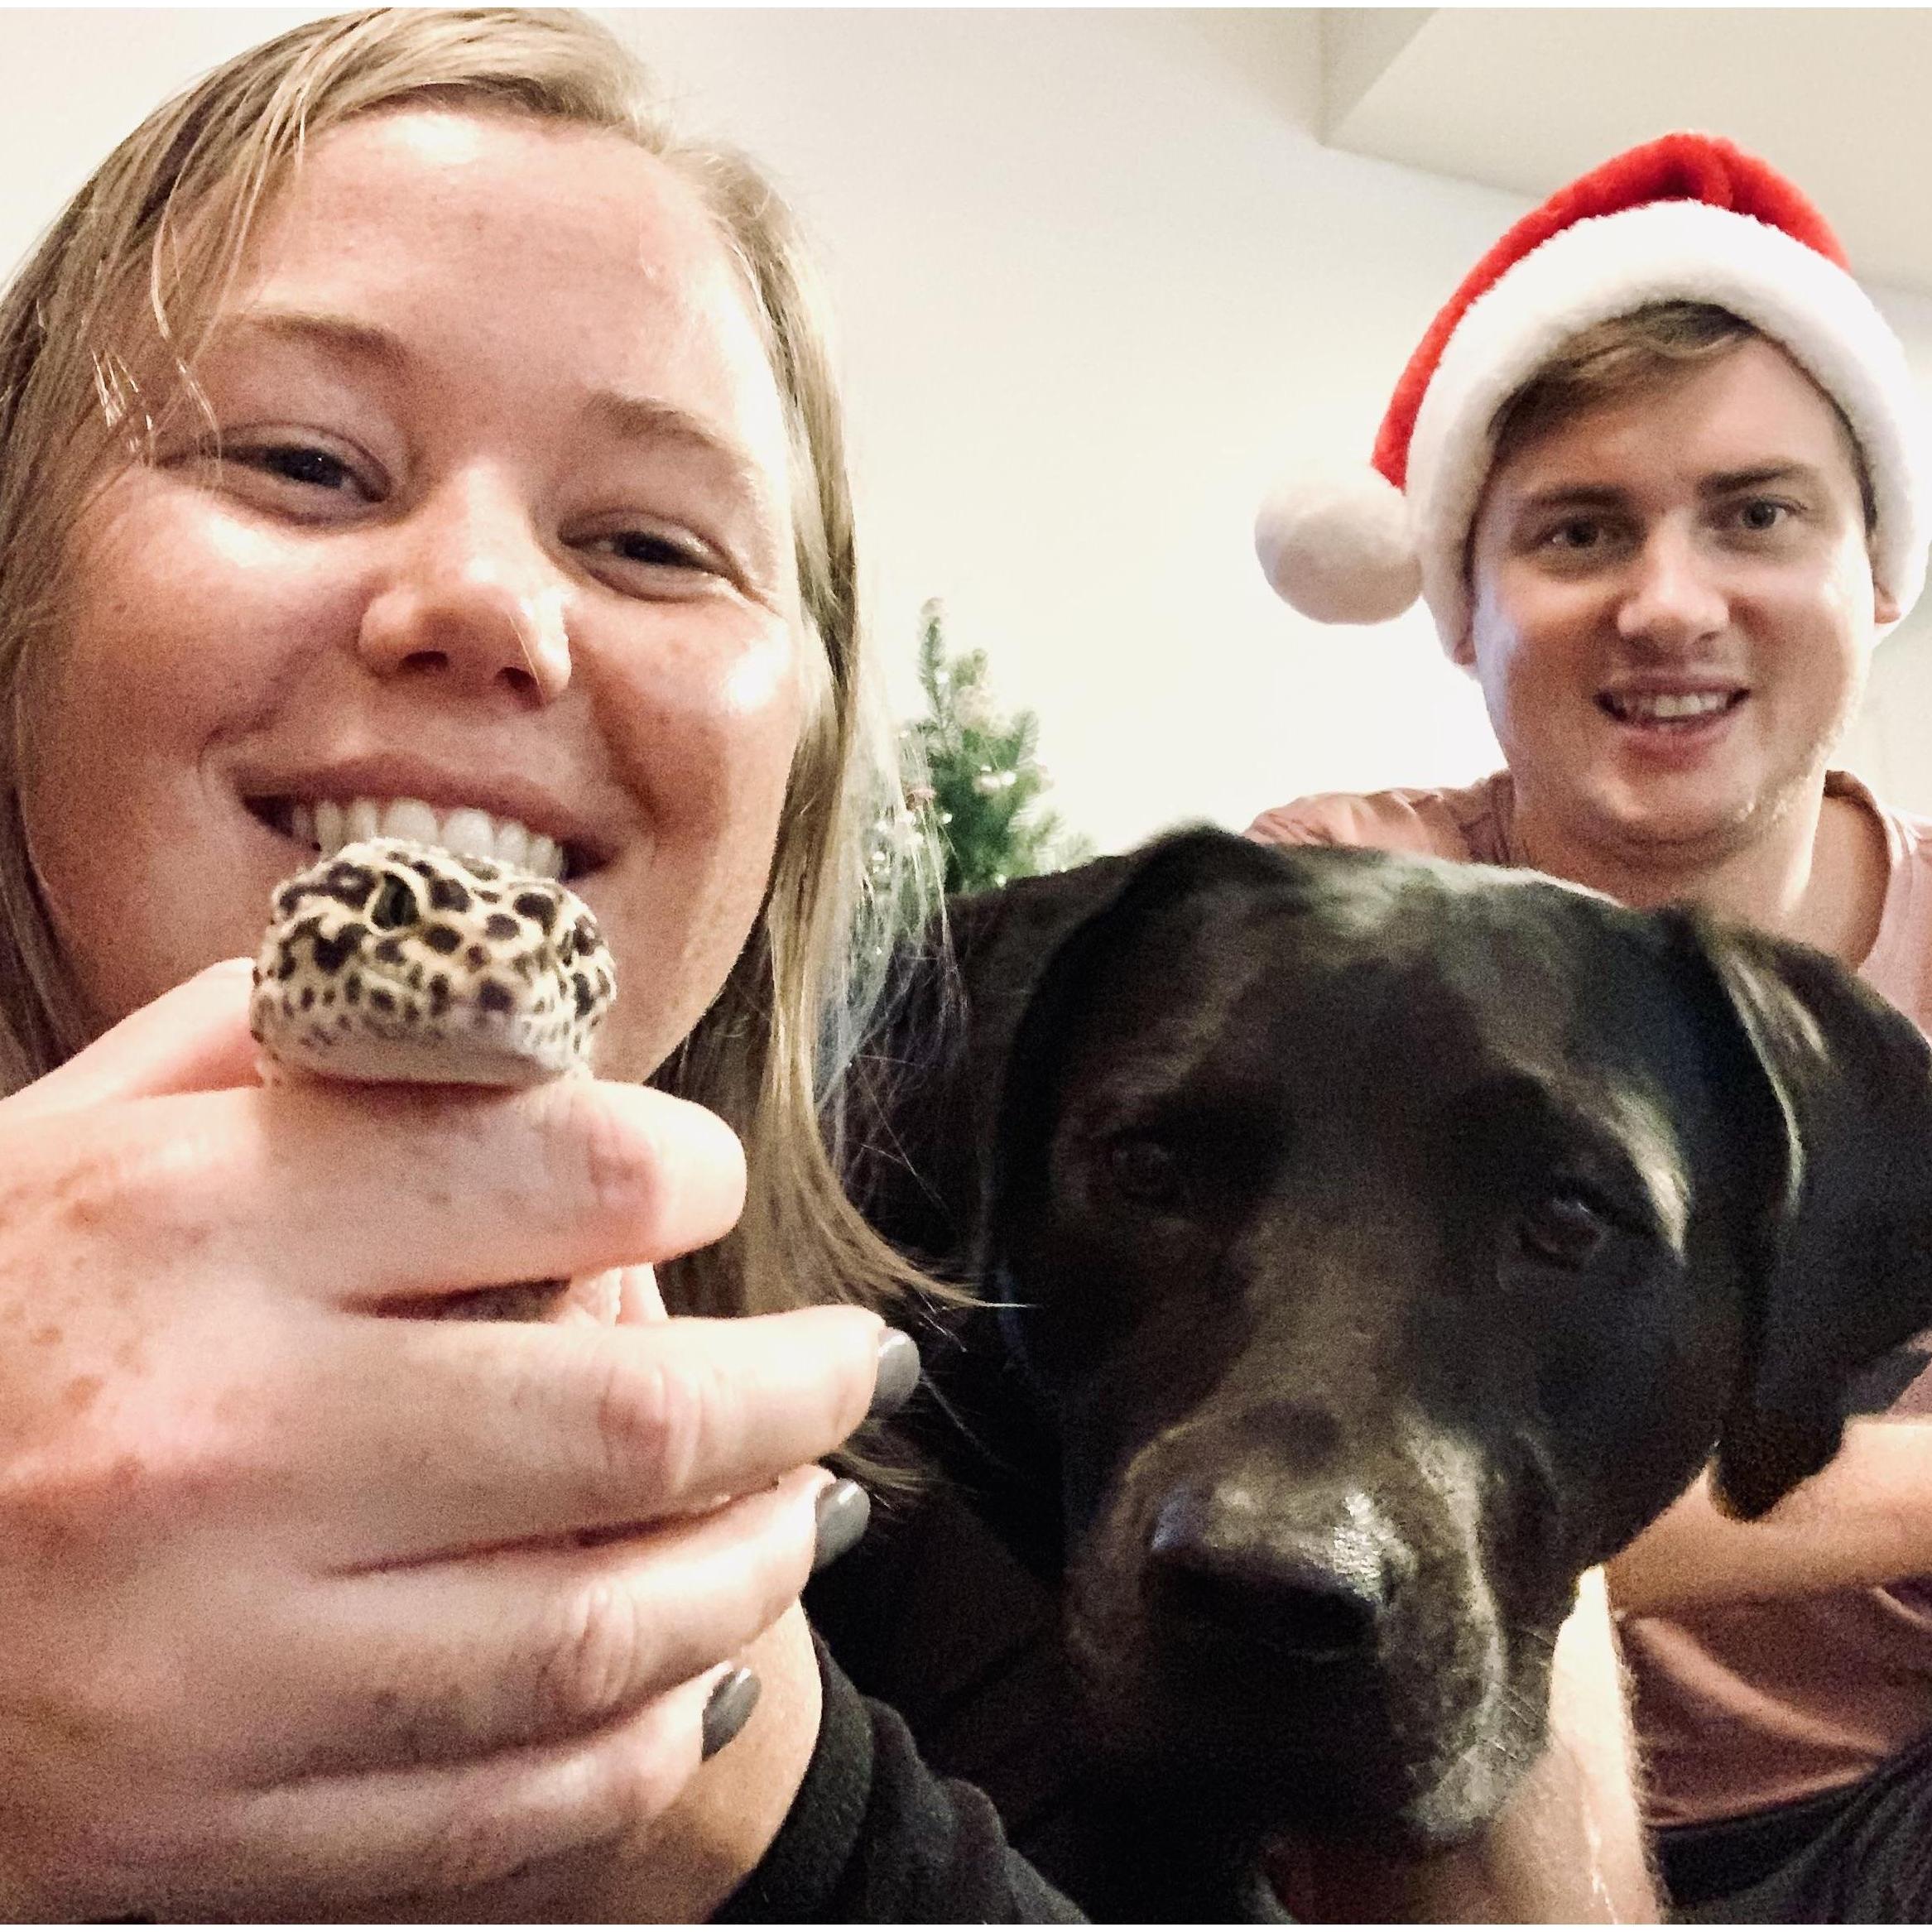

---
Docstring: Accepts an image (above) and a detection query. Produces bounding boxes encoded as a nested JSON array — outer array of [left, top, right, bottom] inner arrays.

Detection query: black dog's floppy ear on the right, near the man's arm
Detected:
[[1671, 914, 1932, 1519]]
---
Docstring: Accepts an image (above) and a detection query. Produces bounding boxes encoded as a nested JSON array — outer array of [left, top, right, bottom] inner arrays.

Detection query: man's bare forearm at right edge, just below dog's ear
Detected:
[[1609, 1416, 1932, 1617]]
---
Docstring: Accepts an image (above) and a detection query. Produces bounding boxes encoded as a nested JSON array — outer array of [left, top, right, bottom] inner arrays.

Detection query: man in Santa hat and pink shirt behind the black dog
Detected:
[[1252, 135, 1932, 1920]]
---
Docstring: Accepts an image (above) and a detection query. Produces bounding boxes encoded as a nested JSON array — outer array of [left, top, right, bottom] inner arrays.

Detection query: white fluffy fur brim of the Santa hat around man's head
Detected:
[[1406, 201, 1928, 651]]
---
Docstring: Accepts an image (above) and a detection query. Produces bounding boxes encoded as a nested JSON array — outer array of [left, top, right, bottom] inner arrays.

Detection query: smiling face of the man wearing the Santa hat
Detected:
[[1457, 338, 1897, 863]]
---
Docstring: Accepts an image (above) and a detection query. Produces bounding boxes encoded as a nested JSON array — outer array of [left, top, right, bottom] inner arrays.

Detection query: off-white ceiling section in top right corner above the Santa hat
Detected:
[[1321, 7, 1932, 291]]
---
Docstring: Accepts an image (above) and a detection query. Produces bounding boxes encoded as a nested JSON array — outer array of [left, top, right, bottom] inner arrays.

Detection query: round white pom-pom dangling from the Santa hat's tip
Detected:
[[1254, 464, 1422, 624]]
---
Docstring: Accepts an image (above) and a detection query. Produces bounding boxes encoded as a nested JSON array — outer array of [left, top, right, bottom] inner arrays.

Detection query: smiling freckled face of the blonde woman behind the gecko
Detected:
[[23, 110, 817, 1078]]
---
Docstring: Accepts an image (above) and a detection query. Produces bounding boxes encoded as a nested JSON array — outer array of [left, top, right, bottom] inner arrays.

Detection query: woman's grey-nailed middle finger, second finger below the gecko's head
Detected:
[[278, 1306, 910, 1571]]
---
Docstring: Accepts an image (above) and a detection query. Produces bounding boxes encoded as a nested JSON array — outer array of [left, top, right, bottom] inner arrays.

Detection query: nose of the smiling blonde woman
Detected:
[[358, 479, 570, 704]]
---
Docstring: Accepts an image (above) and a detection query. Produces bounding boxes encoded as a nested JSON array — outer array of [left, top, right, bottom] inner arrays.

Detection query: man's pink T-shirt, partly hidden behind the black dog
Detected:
[[1248, 771, 1932, 1824]]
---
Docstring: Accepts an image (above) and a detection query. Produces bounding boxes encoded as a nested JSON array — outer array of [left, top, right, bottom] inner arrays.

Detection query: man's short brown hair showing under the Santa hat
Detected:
[[1490, 301, 1878, 536]]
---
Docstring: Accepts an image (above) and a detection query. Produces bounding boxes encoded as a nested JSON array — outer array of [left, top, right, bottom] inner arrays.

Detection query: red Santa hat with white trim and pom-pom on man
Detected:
[[1254, 133, 1932, 649]]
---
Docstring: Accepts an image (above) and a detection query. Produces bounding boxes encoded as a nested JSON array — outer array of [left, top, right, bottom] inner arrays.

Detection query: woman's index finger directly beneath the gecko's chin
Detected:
[[99, 1080, 746, 1308]]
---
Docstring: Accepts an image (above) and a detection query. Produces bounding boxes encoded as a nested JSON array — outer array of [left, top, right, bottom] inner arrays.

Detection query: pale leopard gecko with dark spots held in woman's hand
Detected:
[[249, 839, 617, 1319]]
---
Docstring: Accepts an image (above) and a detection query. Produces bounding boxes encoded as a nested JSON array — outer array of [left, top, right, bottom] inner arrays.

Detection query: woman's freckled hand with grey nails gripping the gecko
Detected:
[[0, 968, 881, 1919]]
